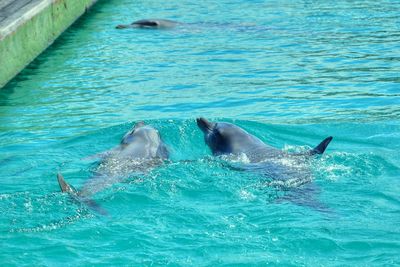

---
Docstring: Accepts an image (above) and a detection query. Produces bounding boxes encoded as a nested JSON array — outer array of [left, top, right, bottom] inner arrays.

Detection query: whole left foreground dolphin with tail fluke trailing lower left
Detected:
[[57, 122, 169, 213]]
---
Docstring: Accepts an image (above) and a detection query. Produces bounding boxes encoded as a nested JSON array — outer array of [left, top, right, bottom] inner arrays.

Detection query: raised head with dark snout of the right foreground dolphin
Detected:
[[197, 118, 253, 155]]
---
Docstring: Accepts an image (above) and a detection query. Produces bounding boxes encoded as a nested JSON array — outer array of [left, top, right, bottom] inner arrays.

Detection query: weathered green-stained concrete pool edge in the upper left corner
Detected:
[[0, 0, 97, 88]]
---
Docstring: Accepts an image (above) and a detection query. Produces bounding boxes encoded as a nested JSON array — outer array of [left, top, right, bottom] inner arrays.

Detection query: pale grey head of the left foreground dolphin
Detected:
[[121, 121, 161, 145]]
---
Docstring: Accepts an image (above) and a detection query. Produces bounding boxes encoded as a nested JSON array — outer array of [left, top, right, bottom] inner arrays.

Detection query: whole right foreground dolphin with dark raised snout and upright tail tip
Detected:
[[197, 118, 332, 207]]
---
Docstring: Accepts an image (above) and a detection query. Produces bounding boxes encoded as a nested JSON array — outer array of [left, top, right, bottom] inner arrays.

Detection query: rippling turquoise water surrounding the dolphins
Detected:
[[0, 0, 400, 266]]
